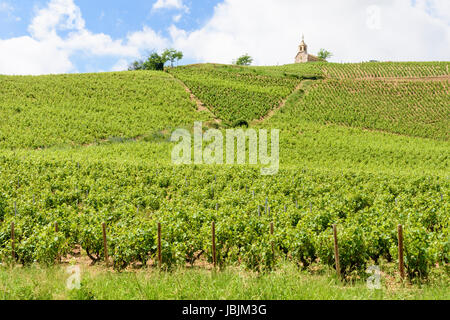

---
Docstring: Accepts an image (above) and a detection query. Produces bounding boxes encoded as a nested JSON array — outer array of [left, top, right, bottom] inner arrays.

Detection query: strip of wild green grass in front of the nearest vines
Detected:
[[0, 265, 450, 300]]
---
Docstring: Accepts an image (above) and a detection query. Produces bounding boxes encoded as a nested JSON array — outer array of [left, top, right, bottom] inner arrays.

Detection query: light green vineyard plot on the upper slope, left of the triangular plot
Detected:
[[0, 72, 208, 148]]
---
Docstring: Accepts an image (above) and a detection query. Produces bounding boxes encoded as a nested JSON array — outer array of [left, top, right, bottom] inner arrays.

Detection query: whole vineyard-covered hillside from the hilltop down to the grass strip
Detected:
[[0, 63, 450, 286]]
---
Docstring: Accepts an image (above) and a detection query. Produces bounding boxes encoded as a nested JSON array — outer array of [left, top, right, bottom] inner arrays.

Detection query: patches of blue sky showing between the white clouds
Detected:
[[0, 0, 219, 72]]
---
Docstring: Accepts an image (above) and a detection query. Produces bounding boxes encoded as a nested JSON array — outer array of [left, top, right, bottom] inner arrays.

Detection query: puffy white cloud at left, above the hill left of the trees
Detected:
[[0, 0, 168, 75]]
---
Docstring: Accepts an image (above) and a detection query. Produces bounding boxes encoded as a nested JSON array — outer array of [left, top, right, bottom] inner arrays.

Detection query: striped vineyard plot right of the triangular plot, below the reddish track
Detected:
[[292, 80, 450, 140]]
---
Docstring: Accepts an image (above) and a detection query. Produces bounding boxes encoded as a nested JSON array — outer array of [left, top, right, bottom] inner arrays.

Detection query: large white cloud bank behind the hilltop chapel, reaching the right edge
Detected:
[[170, 0, 450, 65]]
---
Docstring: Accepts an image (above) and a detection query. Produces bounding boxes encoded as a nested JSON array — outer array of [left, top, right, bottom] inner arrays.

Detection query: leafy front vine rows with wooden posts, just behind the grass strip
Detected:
[[0, 159, 450, 277]]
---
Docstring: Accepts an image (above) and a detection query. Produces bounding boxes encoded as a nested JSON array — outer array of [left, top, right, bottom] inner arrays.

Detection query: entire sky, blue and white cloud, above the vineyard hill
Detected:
[[0, 0, 450, 75]]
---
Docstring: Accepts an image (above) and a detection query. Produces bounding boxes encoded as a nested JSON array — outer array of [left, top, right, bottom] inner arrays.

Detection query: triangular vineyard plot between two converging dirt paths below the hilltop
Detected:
[[170, 65, 300, 124]]
